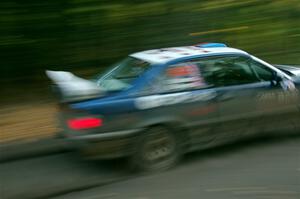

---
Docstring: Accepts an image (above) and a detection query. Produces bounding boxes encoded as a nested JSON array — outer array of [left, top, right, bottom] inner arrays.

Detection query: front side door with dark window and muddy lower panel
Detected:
[[191, 55, 264, 144]]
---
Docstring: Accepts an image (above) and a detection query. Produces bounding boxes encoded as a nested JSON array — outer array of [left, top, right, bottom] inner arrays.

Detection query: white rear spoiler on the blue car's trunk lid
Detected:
[[46, 70, 103, 102]]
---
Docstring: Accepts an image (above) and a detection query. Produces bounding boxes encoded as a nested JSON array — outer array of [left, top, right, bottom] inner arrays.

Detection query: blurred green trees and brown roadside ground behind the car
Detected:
[[0, 0, 300, 143]]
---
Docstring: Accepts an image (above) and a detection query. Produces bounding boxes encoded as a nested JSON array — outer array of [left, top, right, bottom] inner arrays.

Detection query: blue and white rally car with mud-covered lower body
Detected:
[[46, 43, 300, 171]]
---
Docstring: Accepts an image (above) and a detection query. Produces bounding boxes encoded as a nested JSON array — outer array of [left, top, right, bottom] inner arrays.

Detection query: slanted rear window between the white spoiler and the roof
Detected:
[[97, 57, 150, 91]]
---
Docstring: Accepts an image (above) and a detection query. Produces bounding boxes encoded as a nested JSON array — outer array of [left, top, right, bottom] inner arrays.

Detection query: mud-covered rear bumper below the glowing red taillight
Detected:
[[62, 129, 141, 159]]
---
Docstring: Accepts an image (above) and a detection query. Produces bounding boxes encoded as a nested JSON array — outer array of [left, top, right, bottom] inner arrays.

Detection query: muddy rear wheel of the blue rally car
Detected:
[[130, 126, 182, 172]]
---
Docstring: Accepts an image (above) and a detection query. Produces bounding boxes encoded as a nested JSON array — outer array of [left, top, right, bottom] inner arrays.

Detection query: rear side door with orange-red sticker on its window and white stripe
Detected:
[[139, 61, 218, 150]]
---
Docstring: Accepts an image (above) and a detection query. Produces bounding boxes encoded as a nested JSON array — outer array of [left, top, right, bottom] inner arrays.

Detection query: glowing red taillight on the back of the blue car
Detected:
[[68, 117, 103, 130]]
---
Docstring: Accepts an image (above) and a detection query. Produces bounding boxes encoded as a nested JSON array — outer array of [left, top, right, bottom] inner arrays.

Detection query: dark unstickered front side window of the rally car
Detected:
[[194, 57, 259, 87]]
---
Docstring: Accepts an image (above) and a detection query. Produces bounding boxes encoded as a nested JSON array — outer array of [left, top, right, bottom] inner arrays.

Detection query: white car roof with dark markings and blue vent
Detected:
[[130, 45, 248, 64]]
